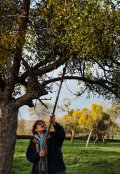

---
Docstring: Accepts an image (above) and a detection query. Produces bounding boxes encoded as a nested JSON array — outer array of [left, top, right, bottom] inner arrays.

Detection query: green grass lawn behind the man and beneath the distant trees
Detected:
[[11, 140, 120, 174]]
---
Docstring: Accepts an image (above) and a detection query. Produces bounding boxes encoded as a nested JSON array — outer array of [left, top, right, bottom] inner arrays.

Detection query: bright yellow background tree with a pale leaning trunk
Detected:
[[79, 103, 109, 148]]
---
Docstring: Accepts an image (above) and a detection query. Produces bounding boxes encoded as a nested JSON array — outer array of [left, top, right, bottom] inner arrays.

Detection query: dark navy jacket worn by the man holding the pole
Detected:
[[26, 123, 66, 174]]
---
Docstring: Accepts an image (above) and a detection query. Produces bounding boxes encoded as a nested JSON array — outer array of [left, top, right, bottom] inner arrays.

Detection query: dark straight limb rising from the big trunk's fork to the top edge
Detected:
[[5, 0, 30, 101]]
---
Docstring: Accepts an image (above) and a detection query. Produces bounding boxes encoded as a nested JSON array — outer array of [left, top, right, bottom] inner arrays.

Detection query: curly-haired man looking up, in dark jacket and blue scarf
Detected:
[[26, 115, 66, 174]]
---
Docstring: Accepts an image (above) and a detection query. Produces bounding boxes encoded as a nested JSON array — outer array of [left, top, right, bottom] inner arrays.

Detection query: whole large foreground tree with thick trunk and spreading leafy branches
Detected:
[[0, 0, 120, 174]]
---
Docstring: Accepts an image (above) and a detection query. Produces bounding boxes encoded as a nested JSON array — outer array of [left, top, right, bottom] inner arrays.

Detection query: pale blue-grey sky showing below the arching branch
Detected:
[[19, 80, 111, 120]]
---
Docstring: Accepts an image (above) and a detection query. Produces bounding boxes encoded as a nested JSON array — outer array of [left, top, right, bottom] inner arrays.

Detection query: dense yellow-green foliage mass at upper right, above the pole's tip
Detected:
[[43, 0, 119, 61]]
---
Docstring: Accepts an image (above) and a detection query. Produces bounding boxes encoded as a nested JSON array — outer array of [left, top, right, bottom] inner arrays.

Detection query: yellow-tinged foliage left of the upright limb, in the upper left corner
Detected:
[[0, 0, 22, 73]]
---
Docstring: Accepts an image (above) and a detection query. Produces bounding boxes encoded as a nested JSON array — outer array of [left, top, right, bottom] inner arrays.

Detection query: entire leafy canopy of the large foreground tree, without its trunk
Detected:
[[0, 0, 120, 102]]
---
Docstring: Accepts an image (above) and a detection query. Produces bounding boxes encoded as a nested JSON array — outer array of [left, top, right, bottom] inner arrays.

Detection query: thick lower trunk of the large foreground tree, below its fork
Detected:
[[0, 104, 18, 174]]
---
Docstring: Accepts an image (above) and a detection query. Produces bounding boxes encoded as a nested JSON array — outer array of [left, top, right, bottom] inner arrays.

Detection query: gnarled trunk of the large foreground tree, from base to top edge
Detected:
[[0, 0, 31, 174]]
